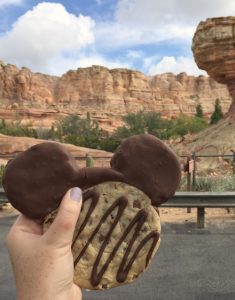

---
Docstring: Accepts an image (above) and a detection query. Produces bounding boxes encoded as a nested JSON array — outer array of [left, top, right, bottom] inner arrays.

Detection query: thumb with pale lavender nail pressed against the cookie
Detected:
[[45, 187, 82, 246]]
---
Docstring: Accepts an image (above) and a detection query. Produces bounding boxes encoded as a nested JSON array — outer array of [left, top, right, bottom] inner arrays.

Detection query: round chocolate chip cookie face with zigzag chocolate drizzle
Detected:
[[44, 182, 161, 290]]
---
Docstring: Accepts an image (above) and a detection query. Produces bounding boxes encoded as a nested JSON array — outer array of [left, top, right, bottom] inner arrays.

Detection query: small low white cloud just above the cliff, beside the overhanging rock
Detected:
[[148, 56, 206, 75]]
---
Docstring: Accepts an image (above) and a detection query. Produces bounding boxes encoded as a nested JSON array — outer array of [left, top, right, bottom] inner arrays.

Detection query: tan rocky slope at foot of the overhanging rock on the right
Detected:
[[171, 118, 235, 175]]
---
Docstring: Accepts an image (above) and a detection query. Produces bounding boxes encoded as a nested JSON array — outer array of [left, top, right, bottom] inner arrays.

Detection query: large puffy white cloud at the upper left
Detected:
[[0, 2, 95, 72]]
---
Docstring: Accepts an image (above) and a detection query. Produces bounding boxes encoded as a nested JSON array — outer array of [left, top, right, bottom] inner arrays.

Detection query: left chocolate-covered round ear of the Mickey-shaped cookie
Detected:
[[3, 142, 78, 218]]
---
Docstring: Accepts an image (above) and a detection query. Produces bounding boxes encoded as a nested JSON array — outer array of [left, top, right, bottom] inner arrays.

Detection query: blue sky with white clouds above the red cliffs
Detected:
[[0, 0, 235, 75]]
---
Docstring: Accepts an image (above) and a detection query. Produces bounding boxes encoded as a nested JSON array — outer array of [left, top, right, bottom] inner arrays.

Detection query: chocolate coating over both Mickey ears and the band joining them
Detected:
[[3, 134, 180, 218]]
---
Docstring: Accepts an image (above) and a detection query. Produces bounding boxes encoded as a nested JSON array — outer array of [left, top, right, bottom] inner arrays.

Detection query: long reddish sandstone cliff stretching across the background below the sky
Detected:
[[0, 62, 231, 131]]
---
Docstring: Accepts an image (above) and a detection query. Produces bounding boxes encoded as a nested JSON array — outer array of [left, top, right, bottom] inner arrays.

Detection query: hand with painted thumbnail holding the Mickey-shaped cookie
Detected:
[[7, 188, 82, 300]]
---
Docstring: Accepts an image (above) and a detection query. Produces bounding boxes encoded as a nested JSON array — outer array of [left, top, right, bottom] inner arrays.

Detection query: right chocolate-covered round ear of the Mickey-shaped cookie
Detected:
[[111, 134, 181, 206]]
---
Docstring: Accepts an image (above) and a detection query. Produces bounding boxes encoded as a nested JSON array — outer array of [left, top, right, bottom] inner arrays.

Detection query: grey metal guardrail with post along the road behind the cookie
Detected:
[[0, 189, 235, 228]]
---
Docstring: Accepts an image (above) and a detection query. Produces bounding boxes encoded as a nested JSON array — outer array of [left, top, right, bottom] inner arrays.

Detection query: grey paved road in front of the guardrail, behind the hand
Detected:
[[0, 213, 235, 300]]
